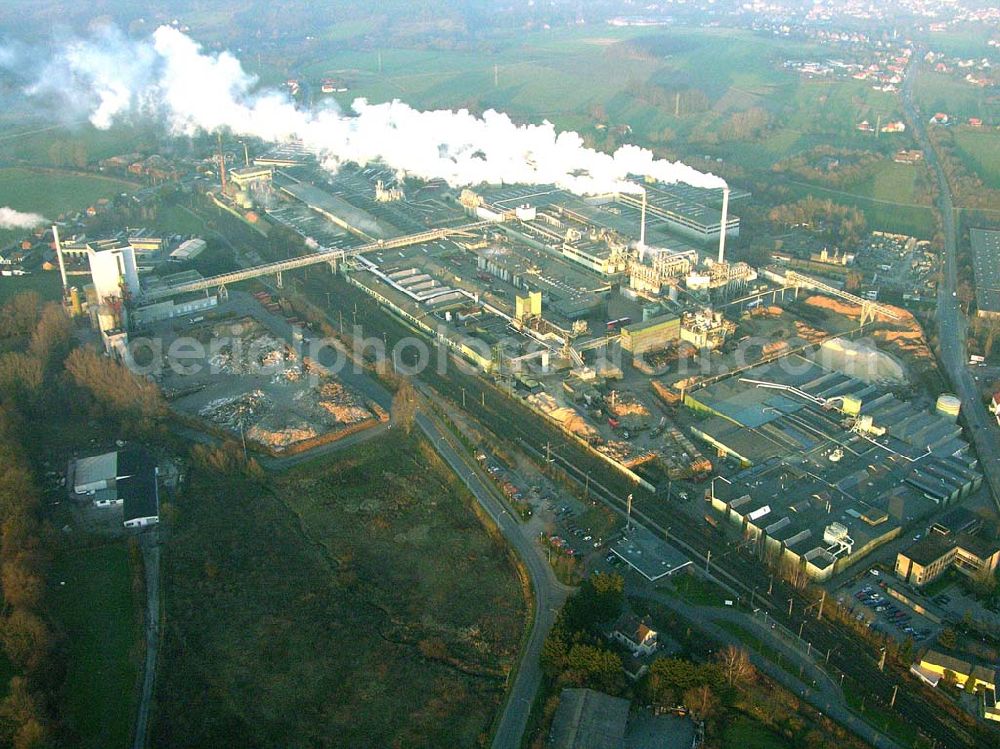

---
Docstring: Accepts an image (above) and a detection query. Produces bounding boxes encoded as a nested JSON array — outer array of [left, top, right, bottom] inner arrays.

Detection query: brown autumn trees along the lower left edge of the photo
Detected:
[[0, 292, 172, 749]]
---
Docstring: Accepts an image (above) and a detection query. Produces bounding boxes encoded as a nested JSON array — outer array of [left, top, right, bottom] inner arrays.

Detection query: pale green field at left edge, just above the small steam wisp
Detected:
[[0, 167, 134, 247]]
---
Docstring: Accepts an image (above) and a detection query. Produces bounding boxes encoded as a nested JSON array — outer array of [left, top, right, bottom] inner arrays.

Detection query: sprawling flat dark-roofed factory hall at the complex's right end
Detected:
[[684, 356, 982, 580]]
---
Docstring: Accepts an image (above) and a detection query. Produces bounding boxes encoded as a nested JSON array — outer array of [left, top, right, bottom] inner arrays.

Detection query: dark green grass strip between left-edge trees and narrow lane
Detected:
[[50, 542, 142, 749]]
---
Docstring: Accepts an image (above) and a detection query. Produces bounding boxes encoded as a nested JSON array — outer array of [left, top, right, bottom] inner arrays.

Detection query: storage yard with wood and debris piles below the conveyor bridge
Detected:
[[145, 300, 387, 454]]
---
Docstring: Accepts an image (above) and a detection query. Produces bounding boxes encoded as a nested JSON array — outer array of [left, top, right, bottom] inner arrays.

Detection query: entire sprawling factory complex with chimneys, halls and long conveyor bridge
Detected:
[[55, 137, 989, 581]]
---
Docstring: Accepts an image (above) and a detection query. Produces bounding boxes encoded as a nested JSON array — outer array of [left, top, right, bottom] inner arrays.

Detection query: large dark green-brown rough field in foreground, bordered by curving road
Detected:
[[153, 429, 525, 747]]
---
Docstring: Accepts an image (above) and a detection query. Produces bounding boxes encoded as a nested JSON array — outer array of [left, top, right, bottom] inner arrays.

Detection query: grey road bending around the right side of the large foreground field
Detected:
[[416, 413, 571, 749]]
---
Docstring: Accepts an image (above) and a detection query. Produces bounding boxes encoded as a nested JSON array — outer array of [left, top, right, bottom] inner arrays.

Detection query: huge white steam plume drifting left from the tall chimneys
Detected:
[[9, 26, 725, 194]]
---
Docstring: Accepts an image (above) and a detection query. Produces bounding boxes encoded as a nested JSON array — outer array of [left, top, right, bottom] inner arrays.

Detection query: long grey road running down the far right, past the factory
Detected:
[[902, 57, 1000, 510]]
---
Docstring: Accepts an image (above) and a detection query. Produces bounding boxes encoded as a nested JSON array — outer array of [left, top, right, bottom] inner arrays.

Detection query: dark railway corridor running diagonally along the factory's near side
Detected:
[[306, 279, 994, 749]]
